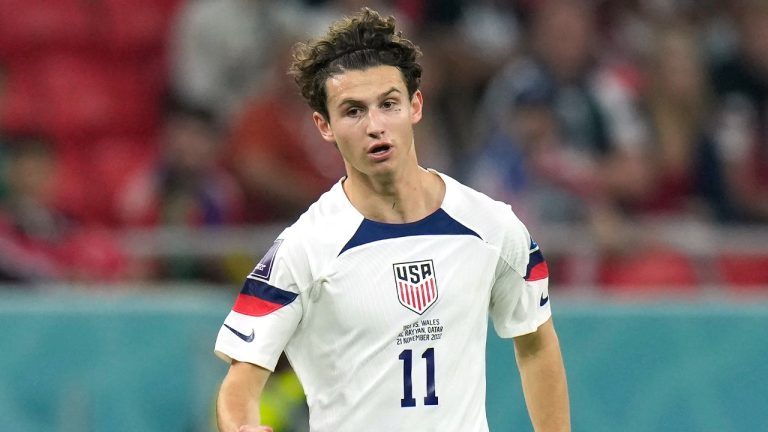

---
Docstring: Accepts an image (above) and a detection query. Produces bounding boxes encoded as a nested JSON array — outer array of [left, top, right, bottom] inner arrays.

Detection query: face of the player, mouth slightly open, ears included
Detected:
[[313, 66, 422, 182]]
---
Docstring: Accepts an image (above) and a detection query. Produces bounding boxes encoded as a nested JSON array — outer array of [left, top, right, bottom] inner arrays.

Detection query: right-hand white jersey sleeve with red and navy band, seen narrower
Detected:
[[490, 215, 552, 338]]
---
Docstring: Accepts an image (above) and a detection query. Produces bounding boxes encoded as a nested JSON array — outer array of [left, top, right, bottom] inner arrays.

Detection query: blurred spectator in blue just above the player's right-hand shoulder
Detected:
[[469, 73, 594, 223]]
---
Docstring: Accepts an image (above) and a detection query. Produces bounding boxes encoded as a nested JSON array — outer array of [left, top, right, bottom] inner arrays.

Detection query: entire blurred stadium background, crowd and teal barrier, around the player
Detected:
[[0, 0, 768, 432]]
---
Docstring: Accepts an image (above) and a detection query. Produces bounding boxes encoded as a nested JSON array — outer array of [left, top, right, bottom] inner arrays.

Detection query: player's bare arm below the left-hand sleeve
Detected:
[[216, 360, 272, 432]]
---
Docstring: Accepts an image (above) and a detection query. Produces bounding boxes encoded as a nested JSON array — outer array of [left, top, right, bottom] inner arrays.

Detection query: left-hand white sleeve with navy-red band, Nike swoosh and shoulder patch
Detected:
[[214, 238, 306, 371]]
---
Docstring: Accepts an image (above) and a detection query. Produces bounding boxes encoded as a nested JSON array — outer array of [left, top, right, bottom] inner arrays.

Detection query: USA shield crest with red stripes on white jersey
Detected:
[[392, 260, 438, 315]]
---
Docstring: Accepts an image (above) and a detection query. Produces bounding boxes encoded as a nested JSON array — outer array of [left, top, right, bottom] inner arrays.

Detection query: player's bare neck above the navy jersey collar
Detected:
[[344, 166, 445, 223]]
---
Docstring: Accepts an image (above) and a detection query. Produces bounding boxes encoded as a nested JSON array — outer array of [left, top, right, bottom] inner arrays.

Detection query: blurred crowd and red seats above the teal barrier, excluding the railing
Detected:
[[0, 0, 768, 289]]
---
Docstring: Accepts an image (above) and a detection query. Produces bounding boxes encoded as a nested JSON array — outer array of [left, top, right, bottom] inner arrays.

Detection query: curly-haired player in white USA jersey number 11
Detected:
[[216, 9, 570, 432]]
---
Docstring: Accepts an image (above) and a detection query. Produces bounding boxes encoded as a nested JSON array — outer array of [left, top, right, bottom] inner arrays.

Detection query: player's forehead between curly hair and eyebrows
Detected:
[[325, 66, 407, 107]]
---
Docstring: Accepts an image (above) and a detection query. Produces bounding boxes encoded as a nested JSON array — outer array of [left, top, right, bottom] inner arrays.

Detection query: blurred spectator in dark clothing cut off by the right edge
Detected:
[[712, 0, 768, 223]]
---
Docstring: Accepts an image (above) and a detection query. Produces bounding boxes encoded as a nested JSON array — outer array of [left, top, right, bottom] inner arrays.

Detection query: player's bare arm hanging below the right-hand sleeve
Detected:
[[515, 318, 571, 432]]
